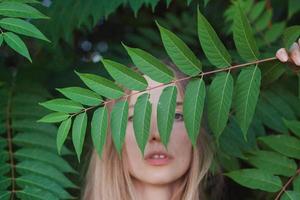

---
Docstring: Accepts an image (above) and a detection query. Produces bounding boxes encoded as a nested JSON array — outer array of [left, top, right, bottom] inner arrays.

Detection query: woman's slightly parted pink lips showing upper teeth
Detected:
[[145, 152, 173, 166]]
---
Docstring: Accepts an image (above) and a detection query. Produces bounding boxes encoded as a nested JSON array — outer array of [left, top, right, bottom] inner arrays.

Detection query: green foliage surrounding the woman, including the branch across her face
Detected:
[[0, 0, 300, 200]]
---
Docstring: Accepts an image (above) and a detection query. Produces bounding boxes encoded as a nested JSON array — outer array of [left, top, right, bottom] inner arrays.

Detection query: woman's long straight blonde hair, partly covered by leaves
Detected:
[[82, 64, 213, 200]]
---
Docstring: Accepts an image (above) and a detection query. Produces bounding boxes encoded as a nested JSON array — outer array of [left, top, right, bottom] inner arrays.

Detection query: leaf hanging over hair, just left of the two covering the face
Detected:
[[111, 100, 128, 157]]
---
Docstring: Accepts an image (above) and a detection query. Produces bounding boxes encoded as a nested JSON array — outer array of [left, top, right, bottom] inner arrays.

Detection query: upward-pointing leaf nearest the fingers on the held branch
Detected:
[[233, 4, 259, 61]]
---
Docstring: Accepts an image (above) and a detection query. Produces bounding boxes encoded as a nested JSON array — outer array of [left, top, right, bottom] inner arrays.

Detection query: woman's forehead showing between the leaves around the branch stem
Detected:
[[129, 76, 183, 105]]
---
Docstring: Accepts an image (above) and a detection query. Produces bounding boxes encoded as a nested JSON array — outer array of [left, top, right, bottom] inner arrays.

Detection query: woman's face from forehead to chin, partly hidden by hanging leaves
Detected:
[[124, 76, 192, 184]]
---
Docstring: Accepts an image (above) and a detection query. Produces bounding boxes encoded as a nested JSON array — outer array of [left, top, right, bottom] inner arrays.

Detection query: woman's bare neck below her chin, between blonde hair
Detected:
[[133, 178, 180, 200]]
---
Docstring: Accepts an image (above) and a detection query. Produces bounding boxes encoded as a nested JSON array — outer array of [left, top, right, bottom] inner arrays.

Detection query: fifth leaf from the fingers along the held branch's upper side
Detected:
[[102, 59, 148, 90]]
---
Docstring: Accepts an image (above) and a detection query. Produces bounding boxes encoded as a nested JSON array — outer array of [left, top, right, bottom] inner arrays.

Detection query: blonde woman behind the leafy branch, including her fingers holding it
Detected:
[[82, 40, 300, 200]]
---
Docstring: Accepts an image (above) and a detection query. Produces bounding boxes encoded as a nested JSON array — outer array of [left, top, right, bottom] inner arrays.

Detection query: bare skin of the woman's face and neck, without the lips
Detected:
[[125, 76, 192, 200]]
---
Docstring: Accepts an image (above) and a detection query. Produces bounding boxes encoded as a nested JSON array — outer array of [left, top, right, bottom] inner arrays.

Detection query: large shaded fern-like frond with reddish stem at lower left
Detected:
[[0, 82, 78, 200]]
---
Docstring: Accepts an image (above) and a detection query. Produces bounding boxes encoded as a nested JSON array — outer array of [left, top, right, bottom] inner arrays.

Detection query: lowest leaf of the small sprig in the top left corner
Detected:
[[3, 32, 32, 62]]
